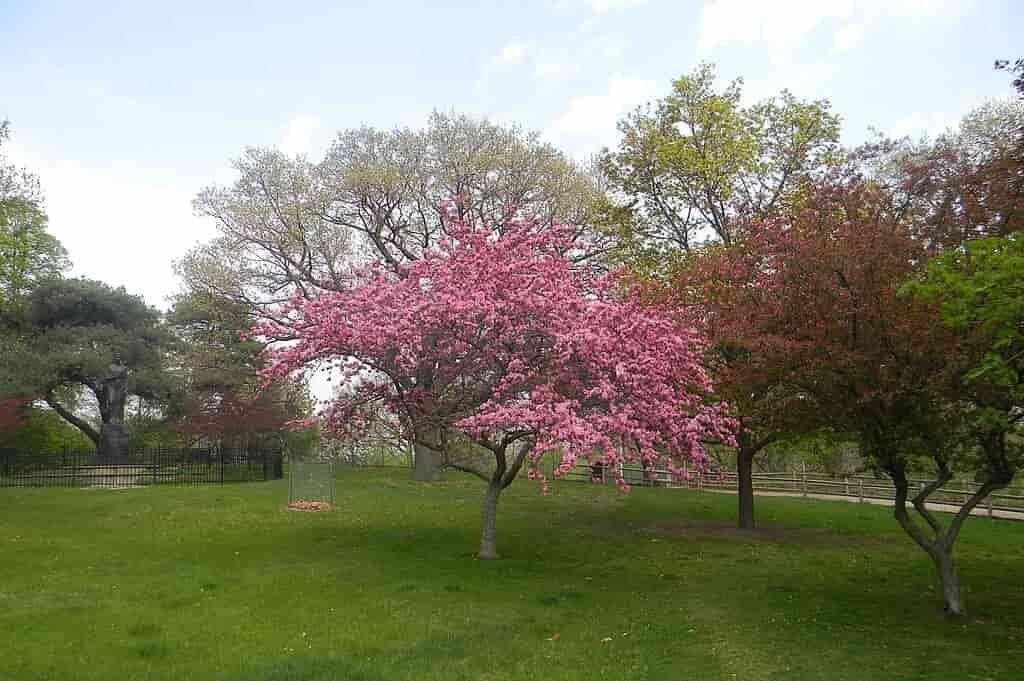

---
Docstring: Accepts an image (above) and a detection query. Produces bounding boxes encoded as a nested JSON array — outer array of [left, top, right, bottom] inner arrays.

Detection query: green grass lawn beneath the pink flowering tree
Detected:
[[0, 469, 1024, 681]]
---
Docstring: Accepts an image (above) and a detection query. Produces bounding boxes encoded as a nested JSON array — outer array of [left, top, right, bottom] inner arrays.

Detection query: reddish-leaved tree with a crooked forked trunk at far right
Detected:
[[704, 176, 1019, 614]]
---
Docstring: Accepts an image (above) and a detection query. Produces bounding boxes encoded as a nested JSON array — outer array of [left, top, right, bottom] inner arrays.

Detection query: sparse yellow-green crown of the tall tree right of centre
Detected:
[[600, 63, 839, 271]]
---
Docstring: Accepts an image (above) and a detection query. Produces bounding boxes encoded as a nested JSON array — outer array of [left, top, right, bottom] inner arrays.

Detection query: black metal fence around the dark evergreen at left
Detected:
[[0, 450, 284, 488]]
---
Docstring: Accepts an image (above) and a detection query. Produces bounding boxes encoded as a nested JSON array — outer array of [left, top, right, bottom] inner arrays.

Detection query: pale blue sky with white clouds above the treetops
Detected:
[[0, 0, 1024, 307]]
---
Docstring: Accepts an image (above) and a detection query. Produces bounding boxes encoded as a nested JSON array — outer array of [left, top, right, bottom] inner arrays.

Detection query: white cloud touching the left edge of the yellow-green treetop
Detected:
[[546, 76, 657, 155]]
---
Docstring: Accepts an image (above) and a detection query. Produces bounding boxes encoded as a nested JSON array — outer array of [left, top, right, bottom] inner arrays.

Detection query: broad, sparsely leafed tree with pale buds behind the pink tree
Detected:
[[179, 113, 605, 480]]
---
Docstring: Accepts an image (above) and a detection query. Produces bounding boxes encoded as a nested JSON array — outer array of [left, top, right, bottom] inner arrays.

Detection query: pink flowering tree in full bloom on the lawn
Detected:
[[255, 210, 732, 558]]
